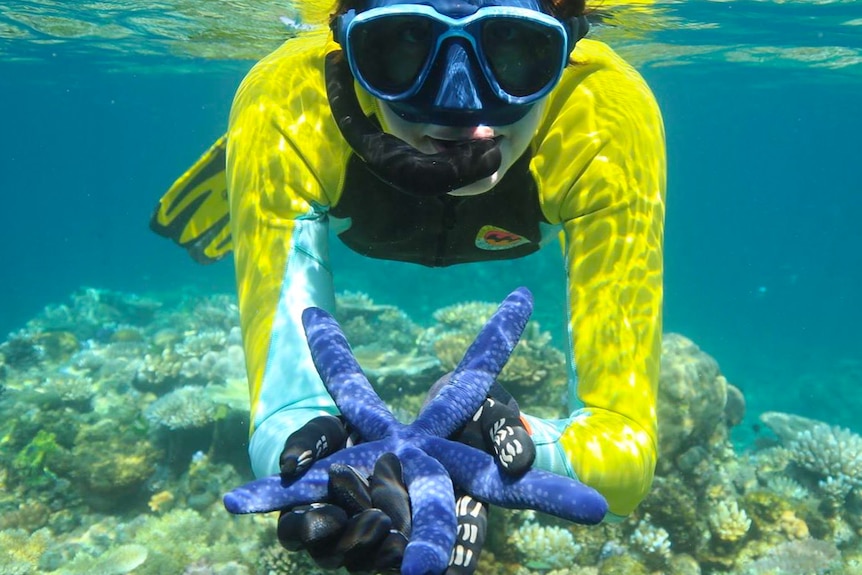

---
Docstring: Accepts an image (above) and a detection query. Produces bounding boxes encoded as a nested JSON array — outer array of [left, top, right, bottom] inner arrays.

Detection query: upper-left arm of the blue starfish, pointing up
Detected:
[[302, 307, 403, 441]]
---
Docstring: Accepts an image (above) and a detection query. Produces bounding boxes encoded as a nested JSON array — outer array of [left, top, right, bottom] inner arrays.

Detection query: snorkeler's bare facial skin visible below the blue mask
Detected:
[[380, 99, 546, 196]]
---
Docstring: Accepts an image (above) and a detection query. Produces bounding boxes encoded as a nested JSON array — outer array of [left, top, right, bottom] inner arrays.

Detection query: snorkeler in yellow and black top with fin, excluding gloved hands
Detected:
[[151, 0, 666, 572]]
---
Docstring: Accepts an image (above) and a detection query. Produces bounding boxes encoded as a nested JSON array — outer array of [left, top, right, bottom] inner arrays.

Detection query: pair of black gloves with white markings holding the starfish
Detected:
[[278, 375, 536, 575]]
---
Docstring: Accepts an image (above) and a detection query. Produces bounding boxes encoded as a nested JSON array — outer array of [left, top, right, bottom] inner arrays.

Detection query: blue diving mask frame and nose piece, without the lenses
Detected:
[[333, 0, 589, 125]]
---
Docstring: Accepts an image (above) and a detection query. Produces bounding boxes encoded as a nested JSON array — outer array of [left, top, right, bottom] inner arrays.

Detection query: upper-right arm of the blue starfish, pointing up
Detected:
[[412, 287, 533, 437]]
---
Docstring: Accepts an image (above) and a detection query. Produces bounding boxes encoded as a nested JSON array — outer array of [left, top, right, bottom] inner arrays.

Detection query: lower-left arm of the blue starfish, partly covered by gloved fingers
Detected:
[[224, 441, 385, 514]]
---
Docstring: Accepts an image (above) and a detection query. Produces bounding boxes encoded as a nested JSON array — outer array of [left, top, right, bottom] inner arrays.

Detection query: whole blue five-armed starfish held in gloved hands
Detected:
[[224, 288, 607, 575]]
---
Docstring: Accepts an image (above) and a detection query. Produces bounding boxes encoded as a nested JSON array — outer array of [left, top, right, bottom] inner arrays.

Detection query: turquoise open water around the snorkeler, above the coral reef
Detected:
[[0, 0, 862, 572]]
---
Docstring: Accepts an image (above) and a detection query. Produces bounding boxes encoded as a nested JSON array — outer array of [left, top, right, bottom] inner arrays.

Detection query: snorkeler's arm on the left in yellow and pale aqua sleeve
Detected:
[[227, 39, 356, 477]]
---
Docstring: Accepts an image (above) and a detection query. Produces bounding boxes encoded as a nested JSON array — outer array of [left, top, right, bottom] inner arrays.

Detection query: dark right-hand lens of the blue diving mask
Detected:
[[482, 18, 564, 97]]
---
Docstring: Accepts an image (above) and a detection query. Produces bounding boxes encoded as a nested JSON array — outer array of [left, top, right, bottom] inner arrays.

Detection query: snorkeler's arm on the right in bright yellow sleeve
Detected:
[[531, 41, 666, 515]]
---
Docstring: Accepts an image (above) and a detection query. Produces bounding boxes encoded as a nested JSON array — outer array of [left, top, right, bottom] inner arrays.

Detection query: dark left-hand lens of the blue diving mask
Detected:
[[350, 15, 433, 95]]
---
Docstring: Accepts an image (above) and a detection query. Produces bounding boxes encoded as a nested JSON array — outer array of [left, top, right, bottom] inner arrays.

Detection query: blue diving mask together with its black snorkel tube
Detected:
[[325, 0, 585, 196]]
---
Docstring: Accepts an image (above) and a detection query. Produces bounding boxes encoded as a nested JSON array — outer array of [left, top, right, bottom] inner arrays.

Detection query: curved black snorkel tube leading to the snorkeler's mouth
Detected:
[[325, 51, 502, 197]]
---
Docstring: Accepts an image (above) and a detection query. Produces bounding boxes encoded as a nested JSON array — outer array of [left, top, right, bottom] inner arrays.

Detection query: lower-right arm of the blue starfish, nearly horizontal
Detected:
[[423, 437, 608, 525]]
